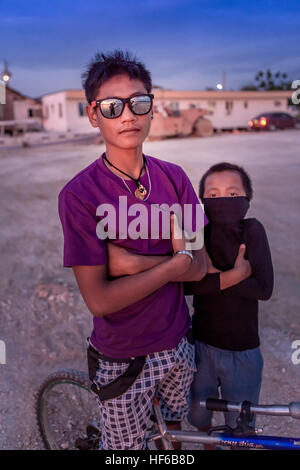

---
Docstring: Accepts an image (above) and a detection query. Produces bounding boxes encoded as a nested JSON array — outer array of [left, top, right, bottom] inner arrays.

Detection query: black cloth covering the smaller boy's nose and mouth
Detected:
[[202, 196, 249, 224]]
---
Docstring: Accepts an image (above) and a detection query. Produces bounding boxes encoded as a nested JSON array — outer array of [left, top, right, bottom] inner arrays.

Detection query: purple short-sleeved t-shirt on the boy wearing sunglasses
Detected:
[[59, 155, 204, 358]]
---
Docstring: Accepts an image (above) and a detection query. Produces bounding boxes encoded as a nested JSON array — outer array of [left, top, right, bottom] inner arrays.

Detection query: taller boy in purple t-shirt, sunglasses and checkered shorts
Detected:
[[59, 51, 206, 450]]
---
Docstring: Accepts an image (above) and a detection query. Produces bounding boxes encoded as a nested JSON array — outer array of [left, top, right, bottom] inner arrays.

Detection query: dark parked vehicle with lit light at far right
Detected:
[[249, 113, 300, 131]]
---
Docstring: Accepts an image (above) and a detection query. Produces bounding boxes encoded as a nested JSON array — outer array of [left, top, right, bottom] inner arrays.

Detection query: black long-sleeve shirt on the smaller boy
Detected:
[[184, 218, 273, 351]]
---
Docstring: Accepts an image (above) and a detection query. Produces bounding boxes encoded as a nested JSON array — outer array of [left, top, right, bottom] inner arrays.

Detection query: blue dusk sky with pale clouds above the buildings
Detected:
[[0, 0, 300, 97]]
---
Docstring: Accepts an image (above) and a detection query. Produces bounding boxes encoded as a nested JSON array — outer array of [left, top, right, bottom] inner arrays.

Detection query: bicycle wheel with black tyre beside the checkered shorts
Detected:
[[36, 369, 101, 450]]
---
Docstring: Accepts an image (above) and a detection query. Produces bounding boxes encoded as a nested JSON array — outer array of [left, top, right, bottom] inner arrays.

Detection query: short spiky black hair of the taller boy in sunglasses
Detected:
[[81, 50, 152, 103]]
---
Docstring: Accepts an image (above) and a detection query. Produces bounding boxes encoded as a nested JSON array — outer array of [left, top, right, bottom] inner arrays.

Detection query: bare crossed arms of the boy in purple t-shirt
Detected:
[[72, 215, 207, 317]]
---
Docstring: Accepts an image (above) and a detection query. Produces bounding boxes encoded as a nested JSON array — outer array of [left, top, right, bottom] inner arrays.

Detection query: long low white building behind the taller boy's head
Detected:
[[42, 88, 292, 133]]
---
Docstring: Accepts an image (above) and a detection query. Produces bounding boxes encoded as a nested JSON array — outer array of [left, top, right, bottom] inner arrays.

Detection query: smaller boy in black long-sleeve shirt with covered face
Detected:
[[184, 162, 273, 448]]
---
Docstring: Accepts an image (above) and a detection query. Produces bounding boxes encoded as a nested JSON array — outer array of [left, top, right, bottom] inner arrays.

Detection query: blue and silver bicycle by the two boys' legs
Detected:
[[36, 369, 300, 450]]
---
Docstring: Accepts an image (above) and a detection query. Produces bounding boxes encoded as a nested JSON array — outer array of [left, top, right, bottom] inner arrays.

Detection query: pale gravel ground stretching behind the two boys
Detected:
[[0, 130, 300, 449]]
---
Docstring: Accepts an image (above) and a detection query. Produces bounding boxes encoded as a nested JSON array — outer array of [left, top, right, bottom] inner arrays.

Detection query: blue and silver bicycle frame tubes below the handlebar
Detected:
[[147, 397, 300, 450]]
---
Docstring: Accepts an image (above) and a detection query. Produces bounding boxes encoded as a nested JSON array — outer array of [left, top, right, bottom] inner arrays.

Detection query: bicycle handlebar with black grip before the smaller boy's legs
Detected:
[[200, 398, 300, 419]]
